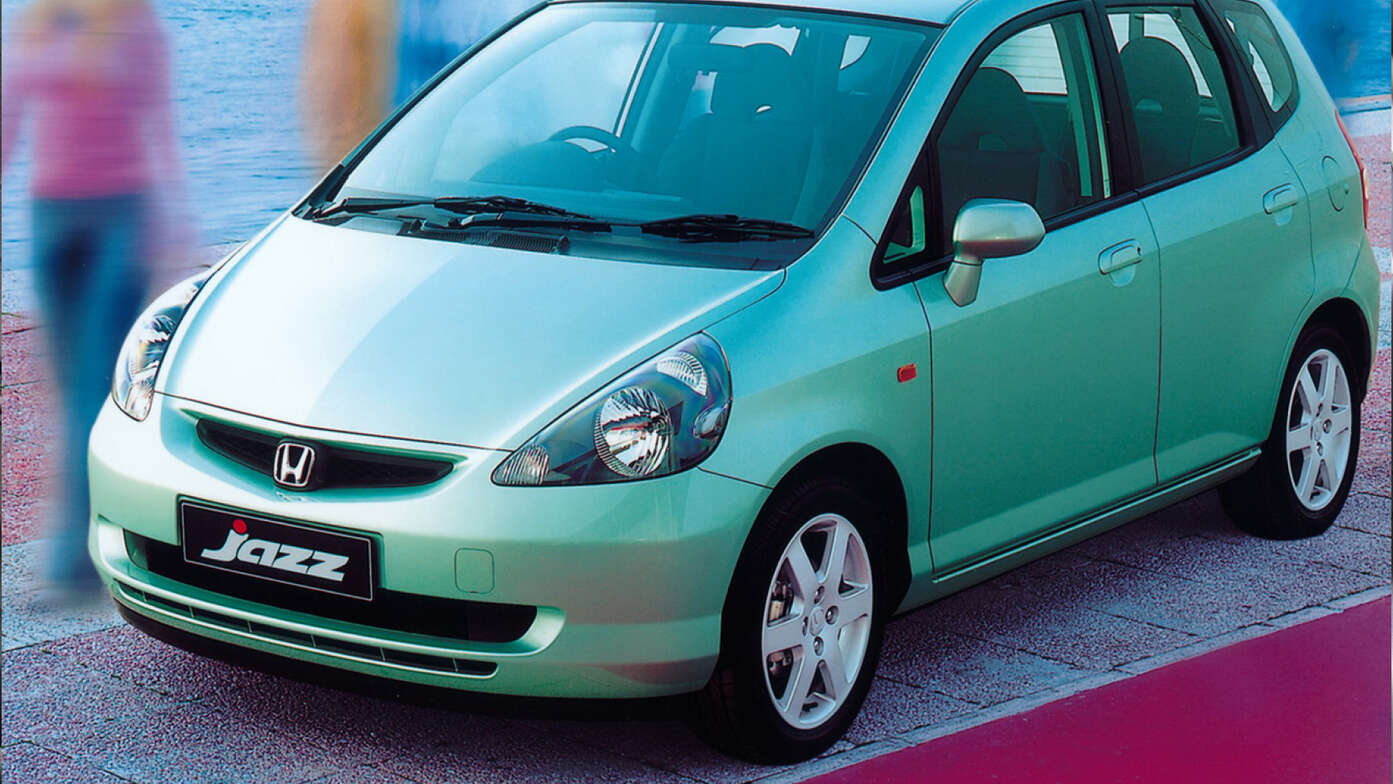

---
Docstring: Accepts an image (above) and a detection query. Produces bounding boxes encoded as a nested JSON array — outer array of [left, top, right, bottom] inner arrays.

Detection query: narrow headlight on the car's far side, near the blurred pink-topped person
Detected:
[[111, 265, 221, 422]]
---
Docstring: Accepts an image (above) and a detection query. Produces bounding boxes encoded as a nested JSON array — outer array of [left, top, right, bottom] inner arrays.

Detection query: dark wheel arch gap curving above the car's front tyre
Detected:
[[761, 441, 912, 611]]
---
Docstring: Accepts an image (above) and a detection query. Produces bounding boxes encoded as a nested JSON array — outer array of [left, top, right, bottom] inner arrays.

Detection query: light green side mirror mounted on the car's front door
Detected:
[[943, 199, 1045, 306]]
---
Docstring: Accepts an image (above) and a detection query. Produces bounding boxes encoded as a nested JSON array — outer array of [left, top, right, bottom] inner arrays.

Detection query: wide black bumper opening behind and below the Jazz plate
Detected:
[[125, 532, 536, 642]]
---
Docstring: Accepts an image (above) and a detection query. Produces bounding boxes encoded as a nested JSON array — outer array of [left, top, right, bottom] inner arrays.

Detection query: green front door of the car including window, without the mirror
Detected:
[[886, 4, 1160, 574]]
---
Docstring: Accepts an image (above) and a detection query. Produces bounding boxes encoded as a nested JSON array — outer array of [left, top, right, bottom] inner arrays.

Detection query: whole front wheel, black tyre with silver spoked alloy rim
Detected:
[[692, 479, 889, 763]]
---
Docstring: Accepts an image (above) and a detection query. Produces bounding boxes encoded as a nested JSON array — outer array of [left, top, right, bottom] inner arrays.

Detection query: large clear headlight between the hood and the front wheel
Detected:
[[493, 334, 730, 487]]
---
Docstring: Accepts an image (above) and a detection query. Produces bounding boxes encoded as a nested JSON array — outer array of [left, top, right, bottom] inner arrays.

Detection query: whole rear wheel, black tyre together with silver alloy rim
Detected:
[[1220, 324, 1364, 539]]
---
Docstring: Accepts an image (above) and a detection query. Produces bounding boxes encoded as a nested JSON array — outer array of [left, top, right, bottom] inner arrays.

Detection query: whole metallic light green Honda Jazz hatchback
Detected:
[[91, 0, 1379, 762]]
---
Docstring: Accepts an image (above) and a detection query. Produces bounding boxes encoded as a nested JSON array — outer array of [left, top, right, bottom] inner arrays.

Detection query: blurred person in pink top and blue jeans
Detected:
[[0, 0, 188, 597]]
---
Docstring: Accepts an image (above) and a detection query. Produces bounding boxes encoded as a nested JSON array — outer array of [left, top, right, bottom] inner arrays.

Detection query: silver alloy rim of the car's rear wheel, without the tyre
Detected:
[[1287, 348, 1354, 512]]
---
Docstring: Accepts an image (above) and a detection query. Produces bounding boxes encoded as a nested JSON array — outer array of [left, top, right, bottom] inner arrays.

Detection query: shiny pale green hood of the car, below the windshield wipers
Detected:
[[160, 217, 783, 448]]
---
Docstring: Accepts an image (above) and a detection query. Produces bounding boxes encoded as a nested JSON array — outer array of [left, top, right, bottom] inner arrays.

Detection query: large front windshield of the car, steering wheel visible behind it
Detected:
[[334, 3, 936, 266]]
